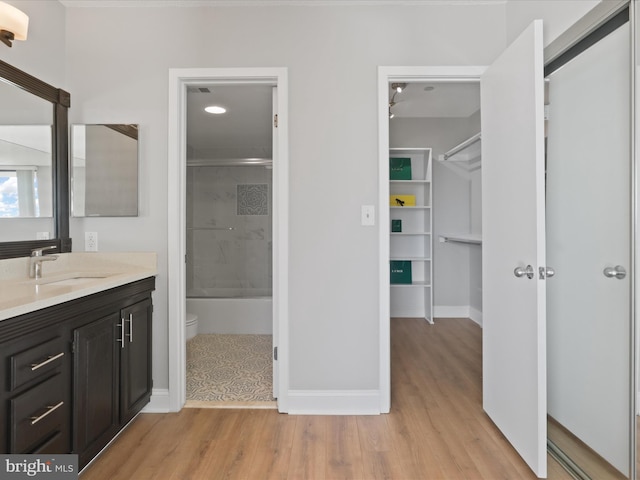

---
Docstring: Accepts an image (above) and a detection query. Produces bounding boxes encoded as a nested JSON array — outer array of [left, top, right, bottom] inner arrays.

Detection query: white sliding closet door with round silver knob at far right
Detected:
[[547, 18, 632, 478]]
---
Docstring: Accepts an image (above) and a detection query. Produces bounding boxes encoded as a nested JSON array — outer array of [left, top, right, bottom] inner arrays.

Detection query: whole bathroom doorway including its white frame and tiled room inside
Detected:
[[169, 68, 288, 410]]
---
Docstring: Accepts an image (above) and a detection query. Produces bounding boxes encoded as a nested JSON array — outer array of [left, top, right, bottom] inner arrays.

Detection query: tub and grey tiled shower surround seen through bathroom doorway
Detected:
[[186, 165, 273, 335]]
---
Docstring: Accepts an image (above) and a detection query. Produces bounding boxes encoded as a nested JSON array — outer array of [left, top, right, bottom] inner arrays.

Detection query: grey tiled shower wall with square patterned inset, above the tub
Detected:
[[186, 166, 272, 298]]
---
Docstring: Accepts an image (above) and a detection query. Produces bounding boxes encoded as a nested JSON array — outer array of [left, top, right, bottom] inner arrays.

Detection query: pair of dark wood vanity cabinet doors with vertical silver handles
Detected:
[[73, 299, 152, 468]]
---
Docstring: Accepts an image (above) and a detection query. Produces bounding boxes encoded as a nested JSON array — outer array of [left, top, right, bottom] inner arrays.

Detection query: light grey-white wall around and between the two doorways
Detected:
[[60, 5, 504, 390]]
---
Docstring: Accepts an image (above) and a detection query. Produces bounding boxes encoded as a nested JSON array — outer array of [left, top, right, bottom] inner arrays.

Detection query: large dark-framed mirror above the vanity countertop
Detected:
[[0, 61, 71, 259]]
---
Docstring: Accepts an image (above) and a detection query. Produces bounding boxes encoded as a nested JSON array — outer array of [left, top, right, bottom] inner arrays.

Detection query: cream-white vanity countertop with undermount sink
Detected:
[[0, 252, 158, 320]]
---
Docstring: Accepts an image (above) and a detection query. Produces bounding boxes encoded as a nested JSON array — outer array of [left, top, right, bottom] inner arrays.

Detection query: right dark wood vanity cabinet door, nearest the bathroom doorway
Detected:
[[120, 300, 152, 425]]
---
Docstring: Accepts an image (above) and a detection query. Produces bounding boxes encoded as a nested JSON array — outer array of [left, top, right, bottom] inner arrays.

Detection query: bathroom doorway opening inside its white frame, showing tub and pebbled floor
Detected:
[[186, 84, 275, 407]]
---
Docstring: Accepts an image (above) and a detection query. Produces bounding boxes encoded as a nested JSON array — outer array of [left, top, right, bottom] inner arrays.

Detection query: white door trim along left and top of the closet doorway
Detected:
[[378, 66, 486, 413]]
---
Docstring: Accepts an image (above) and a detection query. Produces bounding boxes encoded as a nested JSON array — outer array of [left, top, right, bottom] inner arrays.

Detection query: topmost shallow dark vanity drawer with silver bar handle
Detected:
[[10, 337, 65, 390]]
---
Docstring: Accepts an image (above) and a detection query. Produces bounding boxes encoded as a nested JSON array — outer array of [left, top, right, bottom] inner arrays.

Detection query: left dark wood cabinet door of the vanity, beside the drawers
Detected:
[[74, 313, 122, 467]]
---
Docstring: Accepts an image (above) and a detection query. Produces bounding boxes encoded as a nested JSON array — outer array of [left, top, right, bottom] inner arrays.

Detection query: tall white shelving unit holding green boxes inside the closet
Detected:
[[389, 148, 433, 323]]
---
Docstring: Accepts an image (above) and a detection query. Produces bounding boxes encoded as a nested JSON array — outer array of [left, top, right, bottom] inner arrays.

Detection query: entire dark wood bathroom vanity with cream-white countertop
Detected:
[[0, 253, 156, 468]]
